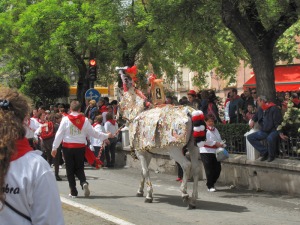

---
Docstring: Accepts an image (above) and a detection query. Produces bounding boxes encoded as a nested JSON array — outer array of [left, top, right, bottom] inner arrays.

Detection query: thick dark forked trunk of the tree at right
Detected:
[[222, 0, 298, 101]]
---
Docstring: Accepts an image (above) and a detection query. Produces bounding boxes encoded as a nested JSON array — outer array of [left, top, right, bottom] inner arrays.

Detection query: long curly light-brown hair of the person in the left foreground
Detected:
[[0, 87, 31, 207]]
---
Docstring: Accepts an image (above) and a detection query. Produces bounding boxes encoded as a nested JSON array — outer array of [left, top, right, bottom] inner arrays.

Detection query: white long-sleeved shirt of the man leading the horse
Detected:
[[52, 112, 108, 149]]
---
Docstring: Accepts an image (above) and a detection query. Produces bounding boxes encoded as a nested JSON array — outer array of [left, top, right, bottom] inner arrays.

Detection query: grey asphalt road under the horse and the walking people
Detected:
[[58, 164, 300, 225]]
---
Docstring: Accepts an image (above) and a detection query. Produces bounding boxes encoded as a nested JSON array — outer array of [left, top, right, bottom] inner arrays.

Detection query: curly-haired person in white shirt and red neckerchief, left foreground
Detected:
[[0, 87, 64, 225]]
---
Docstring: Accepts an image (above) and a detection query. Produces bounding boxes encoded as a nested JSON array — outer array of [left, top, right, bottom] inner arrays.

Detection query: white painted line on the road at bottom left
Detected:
[[60, 197, 135, 225]]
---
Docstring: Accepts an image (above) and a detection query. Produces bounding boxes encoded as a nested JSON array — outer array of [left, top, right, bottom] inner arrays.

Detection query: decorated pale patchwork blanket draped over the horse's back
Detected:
[[129, 105, 190, 151]]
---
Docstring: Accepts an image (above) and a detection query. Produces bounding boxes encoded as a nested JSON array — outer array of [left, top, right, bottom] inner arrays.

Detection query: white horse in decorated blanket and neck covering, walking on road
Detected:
[[117, 68, 200, 209]]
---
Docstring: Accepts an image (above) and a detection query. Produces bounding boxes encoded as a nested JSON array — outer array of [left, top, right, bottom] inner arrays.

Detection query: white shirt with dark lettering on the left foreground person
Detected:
[[0, 151, 65, 225]]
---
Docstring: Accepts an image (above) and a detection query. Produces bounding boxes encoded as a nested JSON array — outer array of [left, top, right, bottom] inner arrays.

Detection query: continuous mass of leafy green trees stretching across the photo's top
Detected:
[[0, 0, 300, 103]]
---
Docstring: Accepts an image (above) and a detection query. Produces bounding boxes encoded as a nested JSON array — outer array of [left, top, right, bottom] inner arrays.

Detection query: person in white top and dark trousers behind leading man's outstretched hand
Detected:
[[104, 112, 119, 168]]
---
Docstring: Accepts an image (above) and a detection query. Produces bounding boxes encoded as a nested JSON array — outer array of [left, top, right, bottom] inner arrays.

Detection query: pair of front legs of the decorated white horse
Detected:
[[136, 151, 153, 203]]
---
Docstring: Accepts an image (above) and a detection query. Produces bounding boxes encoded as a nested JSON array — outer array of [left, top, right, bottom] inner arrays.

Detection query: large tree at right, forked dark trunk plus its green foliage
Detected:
[[145, 0, 299, 100]]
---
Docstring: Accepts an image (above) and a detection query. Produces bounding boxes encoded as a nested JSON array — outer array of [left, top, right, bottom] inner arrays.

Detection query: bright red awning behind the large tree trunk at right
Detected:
[[244, 64, 300, 92]]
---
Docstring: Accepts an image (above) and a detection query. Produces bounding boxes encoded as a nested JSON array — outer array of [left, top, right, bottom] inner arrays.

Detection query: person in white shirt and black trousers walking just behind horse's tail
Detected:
[[199, 114, 224, 192]]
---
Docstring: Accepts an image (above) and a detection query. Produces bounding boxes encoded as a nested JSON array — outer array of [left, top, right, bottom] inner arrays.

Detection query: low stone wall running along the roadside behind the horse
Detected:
[[116, 147, 300, 196]]
